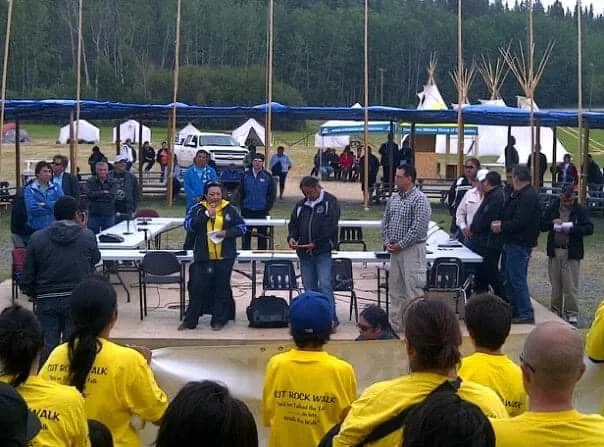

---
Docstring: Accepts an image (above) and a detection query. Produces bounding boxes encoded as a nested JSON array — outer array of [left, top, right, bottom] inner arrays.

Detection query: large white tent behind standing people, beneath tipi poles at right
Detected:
[[478, 97, 568, 164]]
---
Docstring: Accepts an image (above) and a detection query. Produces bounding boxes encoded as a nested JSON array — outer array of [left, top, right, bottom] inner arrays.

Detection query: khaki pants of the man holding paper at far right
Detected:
[[548, 248, 581, 318]]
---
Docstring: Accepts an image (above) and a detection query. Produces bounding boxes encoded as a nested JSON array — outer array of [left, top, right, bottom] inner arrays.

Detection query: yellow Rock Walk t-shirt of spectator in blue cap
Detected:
[[262, 348, 357, 447]]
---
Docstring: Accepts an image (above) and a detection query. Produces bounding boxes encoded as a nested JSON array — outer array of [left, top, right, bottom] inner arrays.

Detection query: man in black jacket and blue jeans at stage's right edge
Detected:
[[491, 166, 541, 324]]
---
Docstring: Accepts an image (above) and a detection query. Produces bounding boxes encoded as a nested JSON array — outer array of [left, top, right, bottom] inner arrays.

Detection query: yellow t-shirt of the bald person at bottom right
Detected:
[[491, 410, 604, 447]]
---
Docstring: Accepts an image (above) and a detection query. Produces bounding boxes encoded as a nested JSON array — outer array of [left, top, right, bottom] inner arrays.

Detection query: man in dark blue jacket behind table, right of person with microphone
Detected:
[[239, 153, 276, 250]]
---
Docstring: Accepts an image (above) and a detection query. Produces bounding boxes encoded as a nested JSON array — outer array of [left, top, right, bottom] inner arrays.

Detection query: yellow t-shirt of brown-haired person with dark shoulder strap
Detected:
[[333, 373, 508, 447]]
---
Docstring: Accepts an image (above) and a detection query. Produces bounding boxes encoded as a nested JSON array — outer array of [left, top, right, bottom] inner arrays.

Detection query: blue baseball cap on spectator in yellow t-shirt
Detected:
[[289, 290, 334, 334]]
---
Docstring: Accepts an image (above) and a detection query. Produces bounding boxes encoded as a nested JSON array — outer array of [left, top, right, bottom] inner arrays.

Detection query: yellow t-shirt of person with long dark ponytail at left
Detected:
[[40, 338, 168, 447]]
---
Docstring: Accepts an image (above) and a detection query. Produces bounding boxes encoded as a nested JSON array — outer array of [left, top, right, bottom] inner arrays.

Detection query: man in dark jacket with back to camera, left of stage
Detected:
[[20, 196, 101, 364]]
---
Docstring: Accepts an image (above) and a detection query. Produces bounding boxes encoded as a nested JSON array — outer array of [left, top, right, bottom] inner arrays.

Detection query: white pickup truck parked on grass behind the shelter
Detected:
[[174, 132, 248, 170]]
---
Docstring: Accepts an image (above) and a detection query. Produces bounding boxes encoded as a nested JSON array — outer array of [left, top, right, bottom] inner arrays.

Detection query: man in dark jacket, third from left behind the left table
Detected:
[[86, 161, 117, 234]]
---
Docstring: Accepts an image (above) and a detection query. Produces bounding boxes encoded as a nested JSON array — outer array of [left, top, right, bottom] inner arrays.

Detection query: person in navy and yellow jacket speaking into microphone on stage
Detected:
[[178, 182, 246, 331]]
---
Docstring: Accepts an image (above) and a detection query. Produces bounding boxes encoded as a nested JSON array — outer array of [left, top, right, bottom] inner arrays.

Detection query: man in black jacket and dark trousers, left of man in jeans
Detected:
[[470, 171, 505, 298]]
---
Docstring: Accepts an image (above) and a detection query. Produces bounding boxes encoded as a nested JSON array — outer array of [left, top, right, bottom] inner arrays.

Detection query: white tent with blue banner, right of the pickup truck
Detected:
[[315, 103, 397, 148]]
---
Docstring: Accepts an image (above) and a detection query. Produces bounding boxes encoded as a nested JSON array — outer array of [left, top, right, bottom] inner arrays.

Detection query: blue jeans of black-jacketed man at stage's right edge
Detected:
[[503, 244, 535, 319]]
